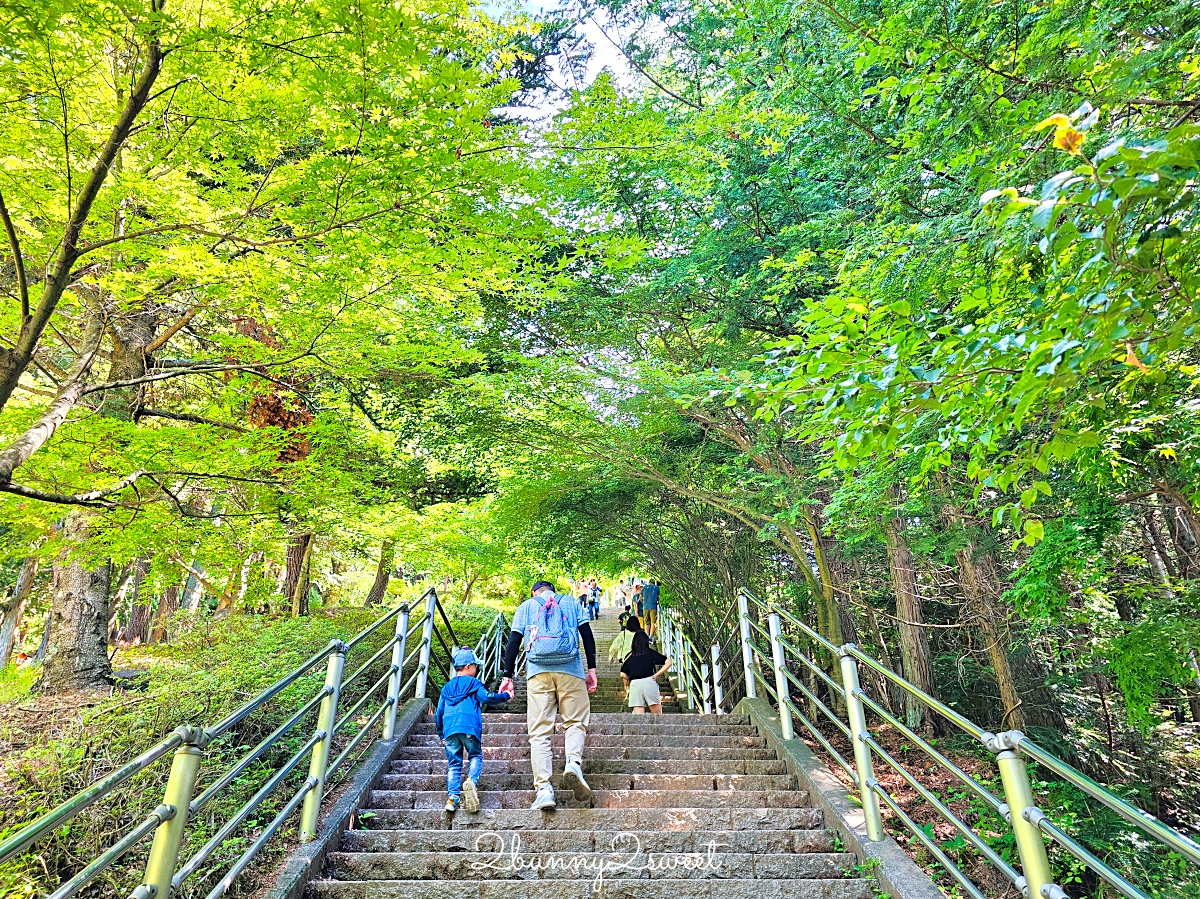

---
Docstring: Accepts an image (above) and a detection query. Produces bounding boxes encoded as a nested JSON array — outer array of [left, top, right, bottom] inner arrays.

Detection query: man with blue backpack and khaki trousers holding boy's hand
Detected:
[[500, 581, 598, 811]]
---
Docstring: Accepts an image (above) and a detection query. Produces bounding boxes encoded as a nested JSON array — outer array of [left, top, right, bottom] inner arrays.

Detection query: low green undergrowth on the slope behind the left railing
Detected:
[[0, 595, 496, 899]]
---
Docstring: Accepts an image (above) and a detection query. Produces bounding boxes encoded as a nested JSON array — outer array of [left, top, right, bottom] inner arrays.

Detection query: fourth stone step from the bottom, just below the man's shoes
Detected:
[[352, 793, 824, 834]]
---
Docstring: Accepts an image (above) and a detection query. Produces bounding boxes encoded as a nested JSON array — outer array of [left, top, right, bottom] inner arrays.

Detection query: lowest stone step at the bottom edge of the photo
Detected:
[[308, 877, 871, 899]]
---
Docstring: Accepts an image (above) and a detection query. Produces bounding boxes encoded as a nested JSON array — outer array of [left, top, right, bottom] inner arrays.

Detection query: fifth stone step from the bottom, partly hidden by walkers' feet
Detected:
[[371, 786, 809, 809]]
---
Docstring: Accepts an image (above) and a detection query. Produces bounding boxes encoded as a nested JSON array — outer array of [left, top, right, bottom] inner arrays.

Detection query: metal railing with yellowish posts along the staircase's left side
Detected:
[[0, 589, 508, 899]]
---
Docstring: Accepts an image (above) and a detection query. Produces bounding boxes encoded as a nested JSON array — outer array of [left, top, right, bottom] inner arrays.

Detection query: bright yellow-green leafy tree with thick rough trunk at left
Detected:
[[0, 0, 561, 689]]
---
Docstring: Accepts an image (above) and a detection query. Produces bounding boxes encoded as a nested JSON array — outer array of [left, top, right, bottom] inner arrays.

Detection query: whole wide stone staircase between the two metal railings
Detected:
[[307, 610, 871, 899]]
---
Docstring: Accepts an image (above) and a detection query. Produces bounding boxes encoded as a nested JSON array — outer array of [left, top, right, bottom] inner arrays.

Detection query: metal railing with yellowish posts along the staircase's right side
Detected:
[[661, 591, 1200, 899]]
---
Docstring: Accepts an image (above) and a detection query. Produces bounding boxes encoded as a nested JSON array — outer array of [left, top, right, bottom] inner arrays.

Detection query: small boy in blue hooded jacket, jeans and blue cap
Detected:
[[437, 647, 512, 811]]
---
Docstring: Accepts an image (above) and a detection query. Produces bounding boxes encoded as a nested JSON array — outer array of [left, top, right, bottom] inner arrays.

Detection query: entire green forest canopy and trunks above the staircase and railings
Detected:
[[0, 0, 1200, 892]]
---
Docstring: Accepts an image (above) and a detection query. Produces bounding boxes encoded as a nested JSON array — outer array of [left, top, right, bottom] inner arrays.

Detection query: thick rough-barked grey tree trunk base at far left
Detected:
[[38, 513, 113, 693]]
